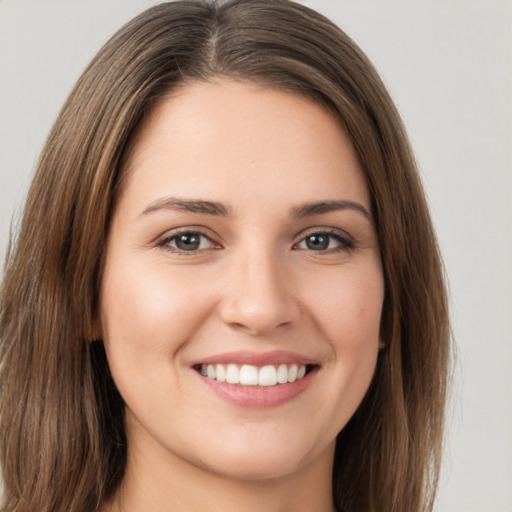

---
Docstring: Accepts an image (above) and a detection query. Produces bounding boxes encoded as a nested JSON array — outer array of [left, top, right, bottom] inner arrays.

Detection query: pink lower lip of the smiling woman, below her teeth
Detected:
[[194, 368, 316, 409]]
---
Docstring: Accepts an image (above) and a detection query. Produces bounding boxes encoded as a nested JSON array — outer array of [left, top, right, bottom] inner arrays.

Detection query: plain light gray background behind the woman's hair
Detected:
[[0, 0, 512, 512]]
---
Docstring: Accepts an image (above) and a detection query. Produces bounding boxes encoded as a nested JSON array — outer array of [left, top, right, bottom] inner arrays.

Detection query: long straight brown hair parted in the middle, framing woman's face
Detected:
[[0, 0, 450, 512]]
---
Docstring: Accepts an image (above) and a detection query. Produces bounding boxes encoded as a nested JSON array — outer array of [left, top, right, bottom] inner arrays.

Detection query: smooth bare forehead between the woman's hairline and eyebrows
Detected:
[[118, 80, 369, 214]]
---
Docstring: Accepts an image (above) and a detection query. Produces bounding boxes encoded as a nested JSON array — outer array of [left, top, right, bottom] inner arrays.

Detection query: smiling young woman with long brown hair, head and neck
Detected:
[[0, 0, 449, 512]]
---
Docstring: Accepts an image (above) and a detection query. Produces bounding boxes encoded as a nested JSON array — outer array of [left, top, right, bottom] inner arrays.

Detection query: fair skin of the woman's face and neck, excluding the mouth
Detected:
[[100, 80, 384, 512]]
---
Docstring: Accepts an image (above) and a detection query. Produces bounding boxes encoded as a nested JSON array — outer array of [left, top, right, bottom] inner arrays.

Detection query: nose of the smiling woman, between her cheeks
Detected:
[[220, 248, 300, 336]]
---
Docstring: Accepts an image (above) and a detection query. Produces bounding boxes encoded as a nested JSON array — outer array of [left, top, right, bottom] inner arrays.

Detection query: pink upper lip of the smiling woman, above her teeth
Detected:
[[191, 350, 318, 366]]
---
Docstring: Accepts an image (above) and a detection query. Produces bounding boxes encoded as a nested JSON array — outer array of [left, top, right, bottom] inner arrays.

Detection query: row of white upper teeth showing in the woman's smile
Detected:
[[200, 364, 306, 387]]
